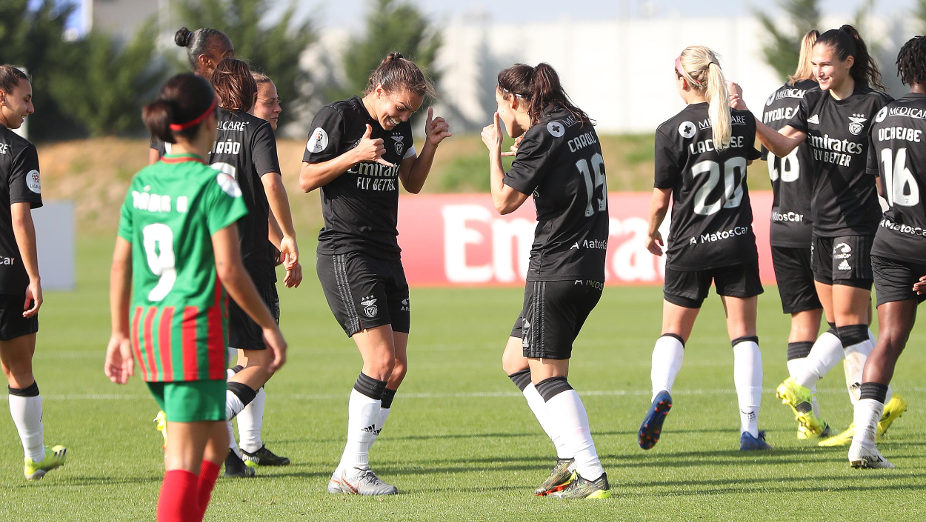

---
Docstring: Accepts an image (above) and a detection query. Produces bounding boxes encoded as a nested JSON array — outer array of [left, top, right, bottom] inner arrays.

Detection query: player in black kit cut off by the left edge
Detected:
[[0, 65, 67, 480]]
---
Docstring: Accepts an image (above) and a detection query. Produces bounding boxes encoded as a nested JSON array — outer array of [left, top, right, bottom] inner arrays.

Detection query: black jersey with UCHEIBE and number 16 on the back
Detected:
[[868, 93, 926, 262]]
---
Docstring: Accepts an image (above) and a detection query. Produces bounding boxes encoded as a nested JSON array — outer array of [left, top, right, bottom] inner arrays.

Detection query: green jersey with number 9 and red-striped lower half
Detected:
[[119, 154, 247, 382]]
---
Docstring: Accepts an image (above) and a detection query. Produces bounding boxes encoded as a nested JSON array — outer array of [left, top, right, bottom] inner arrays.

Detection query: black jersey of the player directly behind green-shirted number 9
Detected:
[[209, 107, 280, 277]]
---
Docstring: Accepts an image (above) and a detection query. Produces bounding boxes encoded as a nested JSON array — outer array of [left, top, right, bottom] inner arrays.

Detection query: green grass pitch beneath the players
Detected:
[[0, 237, 926, 521]]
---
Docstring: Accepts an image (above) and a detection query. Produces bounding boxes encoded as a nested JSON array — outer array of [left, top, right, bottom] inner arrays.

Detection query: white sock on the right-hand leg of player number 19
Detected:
[[544, 389, 604, 480]]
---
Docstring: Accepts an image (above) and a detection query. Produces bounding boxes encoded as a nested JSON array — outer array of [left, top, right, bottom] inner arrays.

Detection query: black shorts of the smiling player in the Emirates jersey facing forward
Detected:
[[811, 236, 874, 290]]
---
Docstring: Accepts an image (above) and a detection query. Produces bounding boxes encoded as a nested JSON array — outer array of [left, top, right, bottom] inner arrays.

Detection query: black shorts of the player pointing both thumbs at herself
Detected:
[[315, 252, 411, 337]]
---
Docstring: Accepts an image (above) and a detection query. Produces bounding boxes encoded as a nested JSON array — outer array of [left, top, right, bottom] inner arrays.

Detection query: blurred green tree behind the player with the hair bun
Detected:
[[174, 0, 318, 125]]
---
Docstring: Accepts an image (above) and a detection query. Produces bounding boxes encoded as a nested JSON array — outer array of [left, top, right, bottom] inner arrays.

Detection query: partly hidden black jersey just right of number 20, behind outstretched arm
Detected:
[[762, 80, 817, 248]]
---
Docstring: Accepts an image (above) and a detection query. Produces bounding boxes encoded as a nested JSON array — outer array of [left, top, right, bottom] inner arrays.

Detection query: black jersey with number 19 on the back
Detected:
[[504, 106, 608, 282]]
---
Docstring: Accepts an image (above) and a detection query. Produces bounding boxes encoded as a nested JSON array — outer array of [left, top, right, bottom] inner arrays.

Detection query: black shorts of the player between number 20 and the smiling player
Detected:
[[772, 245, 823, 314]]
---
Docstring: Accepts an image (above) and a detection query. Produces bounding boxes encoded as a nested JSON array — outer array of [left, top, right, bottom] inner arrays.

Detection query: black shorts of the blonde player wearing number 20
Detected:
[[663, 261, 762, 308]]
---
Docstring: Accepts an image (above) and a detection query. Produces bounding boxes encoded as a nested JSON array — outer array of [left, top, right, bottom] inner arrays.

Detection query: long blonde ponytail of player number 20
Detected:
[[678, 45, 733, 150]]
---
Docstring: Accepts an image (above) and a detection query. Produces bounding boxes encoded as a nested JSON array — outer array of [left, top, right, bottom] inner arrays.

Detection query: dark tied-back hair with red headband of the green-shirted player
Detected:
[[141, 73, 215, 143]]
